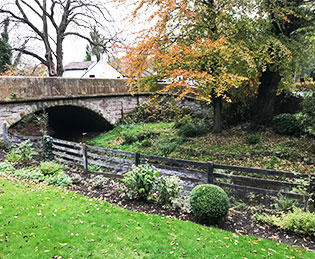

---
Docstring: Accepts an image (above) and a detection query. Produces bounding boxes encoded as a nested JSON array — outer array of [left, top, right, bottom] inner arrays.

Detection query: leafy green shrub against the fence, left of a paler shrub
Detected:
[[123, 164, 160, 200]]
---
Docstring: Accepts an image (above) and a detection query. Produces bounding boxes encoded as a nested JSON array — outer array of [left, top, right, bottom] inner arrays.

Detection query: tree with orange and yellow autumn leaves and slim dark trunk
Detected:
[[117, 0, 255, 132]]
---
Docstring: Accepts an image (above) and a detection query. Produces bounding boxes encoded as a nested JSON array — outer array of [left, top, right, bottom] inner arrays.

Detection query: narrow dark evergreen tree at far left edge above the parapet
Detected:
[[0, 19, 12, 73]]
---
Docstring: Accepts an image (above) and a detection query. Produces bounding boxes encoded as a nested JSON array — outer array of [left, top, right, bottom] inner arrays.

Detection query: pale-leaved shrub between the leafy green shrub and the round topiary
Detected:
[[158, 176, 182, 208]]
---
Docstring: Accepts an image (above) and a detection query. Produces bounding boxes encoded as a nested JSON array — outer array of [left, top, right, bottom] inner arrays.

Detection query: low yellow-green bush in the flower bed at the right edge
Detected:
[[253, 208, 315, 235]]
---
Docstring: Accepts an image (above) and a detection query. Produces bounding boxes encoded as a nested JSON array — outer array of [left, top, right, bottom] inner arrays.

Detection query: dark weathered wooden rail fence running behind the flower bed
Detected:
[[3, 124, 315, 204]]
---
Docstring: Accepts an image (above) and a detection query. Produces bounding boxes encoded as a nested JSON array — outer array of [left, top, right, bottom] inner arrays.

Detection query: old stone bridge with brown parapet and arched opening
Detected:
[[0, 77, 210, 135]]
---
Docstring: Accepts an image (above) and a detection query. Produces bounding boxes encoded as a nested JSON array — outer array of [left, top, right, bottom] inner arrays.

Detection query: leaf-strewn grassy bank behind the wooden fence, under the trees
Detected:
[[87, 123, 315, 173]]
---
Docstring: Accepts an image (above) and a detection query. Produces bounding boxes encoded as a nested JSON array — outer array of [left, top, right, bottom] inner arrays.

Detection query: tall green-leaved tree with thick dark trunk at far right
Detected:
[[256, 0, 315, 123]]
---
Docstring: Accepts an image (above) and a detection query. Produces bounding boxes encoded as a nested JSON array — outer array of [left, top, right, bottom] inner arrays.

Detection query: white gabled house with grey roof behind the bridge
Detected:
[[62, 55, 123, 79]]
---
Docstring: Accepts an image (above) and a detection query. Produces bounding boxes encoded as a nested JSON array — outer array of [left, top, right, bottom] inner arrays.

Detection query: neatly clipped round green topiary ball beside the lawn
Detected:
[[189, 184, 230, 220]]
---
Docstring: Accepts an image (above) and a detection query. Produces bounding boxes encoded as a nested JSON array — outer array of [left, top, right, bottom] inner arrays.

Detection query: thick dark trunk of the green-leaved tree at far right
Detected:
[[258, 68, 281, 124]]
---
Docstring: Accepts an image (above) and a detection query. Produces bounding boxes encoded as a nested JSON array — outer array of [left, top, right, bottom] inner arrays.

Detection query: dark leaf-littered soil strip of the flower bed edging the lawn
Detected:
[[68, 171, 315, 251]]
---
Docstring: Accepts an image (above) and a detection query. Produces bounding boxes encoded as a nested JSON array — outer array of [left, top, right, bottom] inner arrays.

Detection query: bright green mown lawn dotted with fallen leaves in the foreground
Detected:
[[0, 178, 315, 259]]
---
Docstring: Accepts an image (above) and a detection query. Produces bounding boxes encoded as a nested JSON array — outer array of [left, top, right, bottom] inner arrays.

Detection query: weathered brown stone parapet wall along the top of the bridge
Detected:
[[0, 76, 128, 101]]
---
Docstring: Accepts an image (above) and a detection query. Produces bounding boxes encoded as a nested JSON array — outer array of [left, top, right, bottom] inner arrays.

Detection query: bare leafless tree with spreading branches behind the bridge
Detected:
[[0, 0, 117, 76]]
